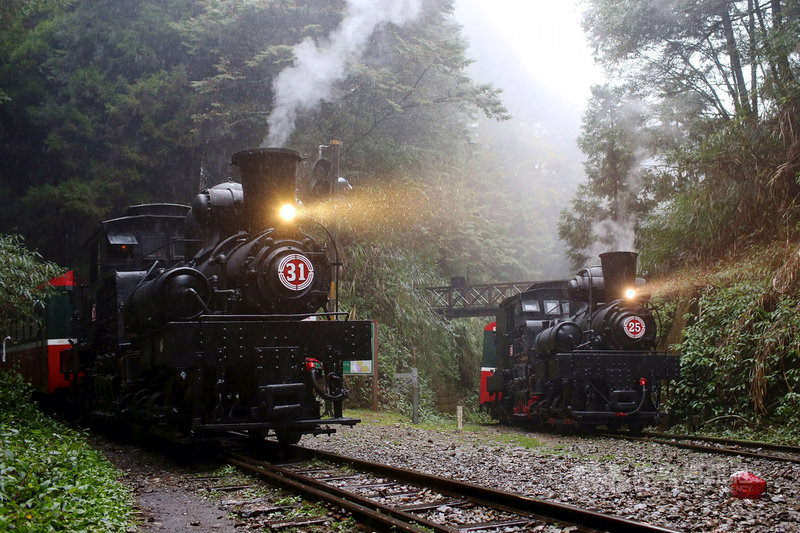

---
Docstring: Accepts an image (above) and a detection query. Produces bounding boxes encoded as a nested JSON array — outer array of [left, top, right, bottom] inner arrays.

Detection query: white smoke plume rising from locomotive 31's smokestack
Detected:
[[261, 0, 421, 147]]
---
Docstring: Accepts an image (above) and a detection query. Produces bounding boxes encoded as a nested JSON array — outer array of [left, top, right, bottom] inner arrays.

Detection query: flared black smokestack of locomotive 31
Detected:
[[231, 148, 302, 233]]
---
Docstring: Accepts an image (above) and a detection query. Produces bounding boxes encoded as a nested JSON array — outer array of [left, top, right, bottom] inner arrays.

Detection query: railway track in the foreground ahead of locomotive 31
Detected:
[[224, 447, 672, 533]]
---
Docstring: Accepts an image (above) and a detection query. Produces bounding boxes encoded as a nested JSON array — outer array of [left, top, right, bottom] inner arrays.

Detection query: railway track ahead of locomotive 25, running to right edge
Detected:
[[604, 433, 800, 463]]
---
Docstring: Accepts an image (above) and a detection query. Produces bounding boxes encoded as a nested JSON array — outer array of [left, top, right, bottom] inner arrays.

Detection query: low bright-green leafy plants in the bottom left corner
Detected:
[[0, 372, 131, 532]]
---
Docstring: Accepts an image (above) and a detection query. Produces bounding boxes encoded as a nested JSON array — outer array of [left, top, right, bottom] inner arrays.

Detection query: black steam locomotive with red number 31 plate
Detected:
[[61, 148, 372, 443]]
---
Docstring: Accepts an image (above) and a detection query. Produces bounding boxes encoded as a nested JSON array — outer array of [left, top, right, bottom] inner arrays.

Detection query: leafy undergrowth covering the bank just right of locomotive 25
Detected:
[[670, 246, 800, 439]]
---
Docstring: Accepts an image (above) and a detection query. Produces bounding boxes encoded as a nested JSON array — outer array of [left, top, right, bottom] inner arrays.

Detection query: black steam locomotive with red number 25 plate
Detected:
[[481, 252, 680, 433]]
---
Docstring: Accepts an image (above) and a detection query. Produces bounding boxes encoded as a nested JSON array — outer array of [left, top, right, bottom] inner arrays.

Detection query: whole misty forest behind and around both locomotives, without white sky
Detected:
[[0, 0, 800, 438]]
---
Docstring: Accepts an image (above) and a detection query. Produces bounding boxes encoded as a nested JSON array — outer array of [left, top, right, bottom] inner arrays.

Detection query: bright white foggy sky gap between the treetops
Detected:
[[455, 0, 603, 150]]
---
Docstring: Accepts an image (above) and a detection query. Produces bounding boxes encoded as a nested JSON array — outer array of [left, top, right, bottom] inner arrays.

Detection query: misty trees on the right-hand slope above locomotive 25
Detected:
[[560, 0, 800, 273]]
